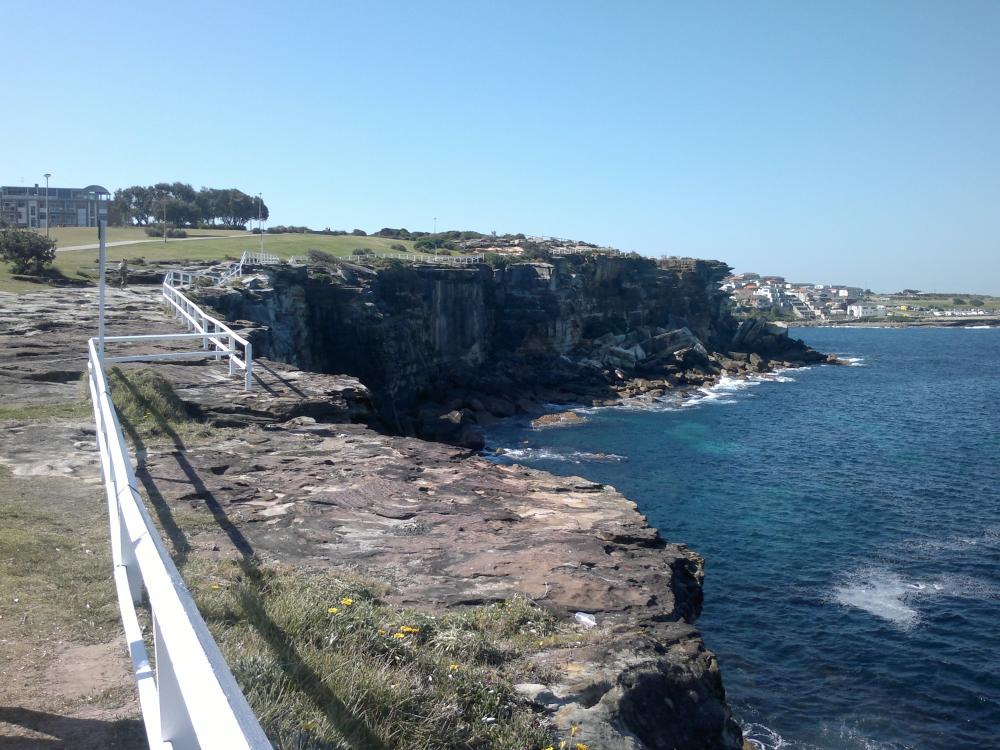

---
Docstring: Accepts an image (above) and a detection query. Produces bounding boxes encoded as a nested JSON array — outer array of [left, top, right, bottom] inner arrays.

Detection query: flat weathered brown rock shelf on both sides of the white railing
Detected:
[[0, 288, 741, 750]]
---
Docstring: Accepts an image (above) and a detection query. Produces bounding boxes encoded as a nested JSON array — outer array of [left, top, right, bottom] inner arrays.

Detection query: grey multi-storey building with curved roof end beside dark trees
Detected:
[[0, 183, 111, 229]]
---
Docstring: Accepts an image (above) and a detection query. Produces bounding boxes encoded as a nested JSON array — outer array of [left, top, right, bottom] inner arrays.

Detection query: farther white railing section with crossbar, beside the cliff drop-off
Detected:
[[158, 271, 253, 391]]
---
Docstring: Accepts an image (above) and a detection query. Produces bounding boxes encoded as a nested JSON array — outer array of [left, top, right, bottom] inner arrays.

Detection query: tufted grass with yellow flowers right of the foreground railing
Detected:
[[184, 560, 564, 750]]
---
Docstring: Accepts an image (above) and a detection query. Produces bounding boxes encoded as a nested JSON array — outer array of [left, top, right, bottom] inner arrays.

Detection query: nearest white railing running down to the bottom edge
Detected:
[[87, 334, 271, 750]]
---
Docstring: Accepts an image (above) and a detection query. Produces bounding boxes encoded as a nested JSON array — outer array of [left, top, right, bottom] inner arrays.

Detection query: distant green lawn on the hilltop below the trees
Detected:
[[0, 235, 422, 294]]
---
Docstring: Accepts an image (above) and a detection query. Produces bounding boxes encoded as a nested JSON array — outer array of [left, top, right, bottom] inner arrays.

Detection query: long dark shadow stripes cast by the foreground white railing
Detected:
[[113, 378, 388, 750]]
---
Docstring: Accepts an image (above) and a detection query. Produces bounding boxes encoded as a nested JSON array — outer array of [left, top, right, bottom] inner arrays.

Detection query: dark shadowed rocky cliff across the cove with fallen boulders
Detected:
[[202, 255, 822, 447]]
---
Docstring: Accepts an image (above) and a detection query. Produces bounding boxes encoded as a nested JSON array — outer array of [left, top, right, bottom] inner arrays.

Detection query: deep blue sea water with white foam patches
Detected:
[[490, 328, 1000, 750]]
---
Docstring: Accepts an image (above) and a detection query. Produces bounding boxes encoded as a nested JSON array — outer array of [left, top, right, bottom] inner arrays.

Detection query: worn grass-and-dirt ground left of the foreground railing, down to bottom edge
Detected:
[[0, 464, 146, 750]]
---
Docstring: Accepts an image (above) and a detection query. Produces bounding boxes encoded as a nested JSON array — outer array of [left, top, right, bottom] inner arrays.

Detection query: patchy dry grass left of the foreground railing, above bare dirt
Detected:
[[0, 467, 119, 643]]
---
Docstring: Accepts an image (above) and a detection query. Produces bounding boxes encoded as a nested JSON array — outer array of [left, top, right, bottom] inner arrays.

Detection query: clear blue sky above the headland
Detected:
[[0, 0, 1000, 294]]
